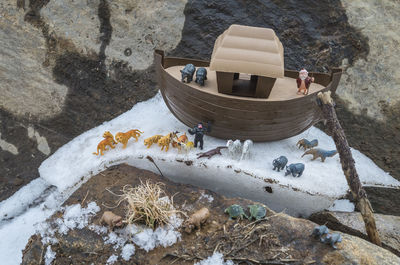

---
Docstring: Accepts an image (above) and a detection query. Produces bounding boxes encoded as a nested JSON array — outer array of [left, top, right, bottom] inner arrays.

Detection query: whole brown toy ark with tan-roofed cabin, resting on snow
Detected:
[[154, 25, 342, 141]]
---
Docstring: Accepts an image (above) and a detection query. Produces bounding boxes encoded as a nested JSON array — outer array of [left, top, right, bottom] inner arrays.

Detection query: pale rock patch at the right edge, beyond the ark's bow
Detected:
[[337, 0, 400, 121]]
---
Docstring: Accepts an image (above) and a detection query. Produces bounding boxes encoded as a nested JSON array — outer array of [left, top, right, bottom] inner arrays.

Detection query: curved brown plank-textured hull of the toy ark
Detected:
[[154, 51, 341, 141]]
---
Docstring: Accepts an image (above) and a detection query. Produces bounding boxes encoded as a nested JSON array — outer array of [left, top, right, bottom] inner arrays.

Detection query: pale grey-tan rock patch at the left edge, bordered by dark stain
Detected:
[[0, 5, 68, 119]]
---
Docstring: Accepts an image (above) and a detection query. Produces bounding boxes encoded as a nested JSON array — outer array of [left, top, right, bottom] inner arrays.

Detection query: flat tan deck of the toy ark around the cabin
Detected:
[[165, 65, 325, 101]]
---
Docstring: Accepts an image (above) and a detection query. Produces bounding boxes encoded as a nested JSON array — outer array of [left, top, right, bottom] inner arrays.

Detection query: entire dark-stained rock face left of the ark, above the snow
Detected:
[[0, 0, 186, 201]]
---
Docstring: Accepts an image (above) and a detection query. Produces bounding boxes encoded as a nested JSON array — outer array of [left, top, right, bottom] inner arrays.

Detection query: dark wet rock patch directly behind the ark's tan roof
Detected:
[[171, 0, 369, 71]]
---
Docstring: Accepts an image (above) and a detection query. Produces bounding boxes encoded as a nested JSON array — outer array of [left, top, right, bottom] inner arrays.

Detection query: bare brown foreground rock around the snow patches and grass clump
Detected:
[[22, 165, 400, 264]]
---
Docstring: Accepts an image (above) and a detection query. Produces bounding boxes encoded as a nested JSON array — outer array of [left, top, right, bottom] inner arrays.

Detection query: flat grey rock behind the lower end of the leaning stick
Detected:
[[309, 209, 400, 256]]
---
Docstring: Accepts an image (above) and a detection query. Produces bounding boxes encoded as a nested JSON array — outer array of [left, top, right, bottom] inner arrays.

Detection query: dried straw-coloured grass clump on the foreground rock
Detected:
[[118, 181, 179, 229]]
